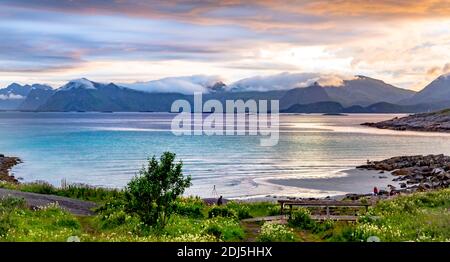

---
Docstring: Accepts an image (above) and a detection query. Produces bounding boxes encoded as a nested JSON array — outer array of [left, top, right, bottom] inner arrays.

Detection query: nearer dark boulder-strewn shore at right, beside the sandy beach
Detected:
[[357, 155, 450, 193]]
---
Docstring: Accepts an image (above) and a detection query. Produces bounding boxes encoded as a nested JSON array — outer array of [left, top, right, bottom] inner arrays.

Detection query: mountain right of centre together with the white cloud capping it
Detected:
[[230, 73, 415, 108]]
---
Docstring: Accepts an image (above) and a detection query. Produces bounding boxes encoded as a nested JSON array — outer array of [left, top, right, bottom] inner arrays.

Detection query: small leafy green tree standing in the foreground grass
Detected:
[[125, 152, 191, 227]]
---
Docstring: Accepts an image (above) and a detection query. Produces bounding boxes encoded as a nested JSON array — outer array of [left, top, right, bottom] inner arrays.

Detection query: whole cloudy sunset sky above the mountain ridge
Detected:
[[0, 0, 450, 90]]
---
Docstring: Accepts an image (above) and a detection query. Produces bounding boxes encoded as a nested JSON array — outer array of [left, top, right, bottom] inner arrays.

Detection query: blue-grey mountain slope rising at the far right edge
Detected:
[[404, 73, 450, 106]]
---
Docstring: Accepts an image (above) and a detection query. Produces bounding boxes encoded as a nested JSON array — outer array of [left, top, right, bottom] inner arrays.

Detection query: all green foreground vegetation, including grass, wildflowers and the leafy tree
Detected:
[[0, 153, 450, 242]]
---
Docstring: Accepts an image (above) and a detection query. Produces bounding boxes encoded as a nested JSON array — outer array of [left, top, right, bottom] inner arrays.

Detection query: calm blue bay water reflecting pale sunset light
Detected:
[[0, 112, 450, 197]]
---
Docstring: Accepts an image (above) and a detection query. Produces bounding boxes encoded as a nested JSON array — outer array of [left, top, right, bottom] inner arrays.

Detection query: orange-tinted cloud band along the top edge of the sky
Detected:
[[2, 0, 450, 29]]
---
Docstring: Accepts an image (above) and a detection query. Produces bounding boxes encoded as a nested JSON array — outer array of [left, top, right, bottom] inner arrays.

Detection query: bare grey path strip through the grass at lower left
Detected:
[[0, 188, 96, 216]]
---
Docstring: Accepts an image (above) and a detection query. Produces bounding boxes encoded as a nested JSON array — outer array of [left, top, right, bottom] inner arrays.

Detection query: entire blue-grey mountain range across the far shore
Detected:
[[0, 74, 450, 113]]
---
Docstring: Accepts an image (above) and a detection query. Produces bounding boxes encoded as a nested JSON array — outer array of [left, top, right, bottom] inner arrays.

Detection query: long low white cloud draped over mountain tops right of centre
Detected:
[[230, 72, 353, 91]]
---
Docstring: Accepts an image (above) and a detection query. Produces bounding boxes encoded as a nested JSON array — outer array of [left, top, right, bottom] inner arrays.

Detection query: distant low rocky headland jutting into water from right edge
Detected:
[[361, 109, 450, 132]]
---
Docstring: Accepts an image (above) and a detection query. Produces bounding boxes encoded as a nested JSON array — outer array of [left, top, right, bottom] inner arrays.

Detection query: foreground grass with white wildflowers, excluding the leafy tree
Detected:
[[0, 184, 450, 242]]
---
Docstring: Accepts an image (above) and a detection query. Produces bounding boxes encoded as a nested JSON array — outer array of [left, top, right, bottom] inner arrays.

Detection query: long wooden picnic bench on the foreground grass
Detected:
[[278, 200, 371, 221]]
